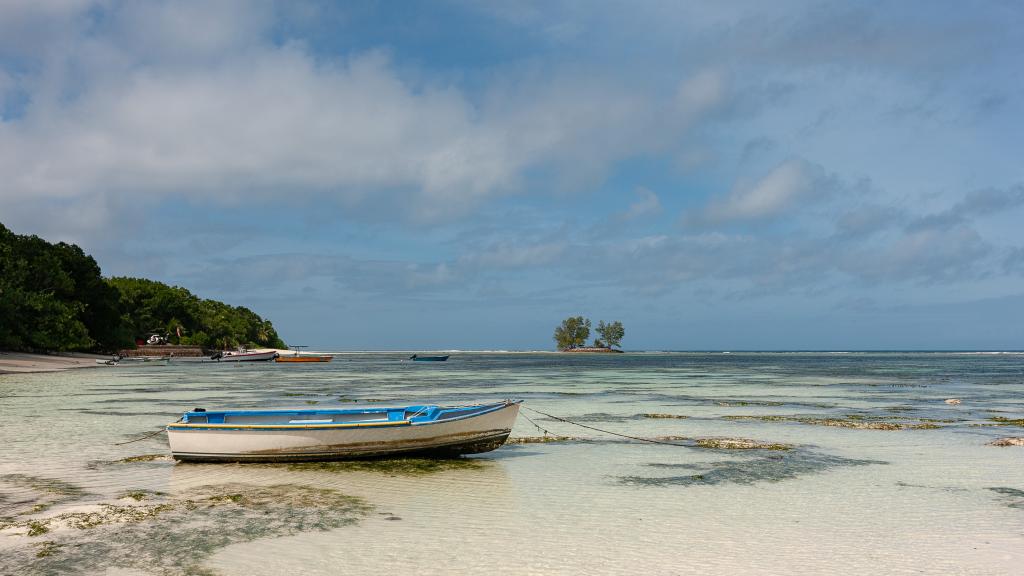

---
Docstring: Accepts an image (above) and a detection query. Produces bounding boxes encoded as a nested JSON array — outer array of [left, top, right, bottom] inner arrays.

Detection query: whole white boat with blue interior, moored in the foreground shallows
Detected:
[[167, 400, 521, 462]]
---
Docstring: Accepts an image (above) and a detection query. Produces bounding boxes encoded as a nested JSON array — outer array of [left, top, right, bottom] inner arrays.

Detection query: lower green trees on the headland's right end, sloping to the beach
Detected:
[[108, 278, 286, 349]]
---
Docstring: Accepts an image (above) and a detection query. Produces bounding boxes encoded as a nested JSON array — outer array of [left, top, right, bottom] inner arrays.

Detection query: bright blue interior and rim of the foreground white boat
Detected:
[[181, 403, 505, 424]]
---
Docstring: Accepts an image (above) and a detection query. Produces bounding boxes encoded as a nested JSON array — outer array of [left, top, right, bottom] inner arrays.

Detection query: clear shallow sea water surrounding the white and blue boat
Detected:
[[0, 353, 1024, 575]]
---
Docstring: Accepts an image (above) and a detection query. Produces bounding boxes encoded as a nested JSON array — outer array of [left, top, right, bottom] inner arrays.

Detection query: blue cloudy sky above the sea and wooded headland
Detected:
[[0, 0, 1024, 351]]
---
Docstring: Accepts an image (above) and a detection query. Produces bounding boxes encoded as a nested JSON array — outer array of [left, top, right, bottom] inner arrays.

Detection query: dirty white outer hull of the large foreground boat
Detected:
[[167, 403, 519, 462]]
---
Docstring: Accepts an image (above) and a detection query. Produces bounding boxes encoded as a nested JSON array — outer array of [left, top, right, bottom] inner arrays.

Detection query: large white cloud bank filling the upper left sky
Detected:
[[0, 1, 722, 227]]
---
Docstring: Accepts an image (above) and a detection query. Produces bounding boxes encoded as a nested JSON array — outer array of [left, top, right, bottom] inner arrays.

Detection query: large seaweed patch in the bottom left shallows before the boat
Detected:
[[0, 484, 372, 575]]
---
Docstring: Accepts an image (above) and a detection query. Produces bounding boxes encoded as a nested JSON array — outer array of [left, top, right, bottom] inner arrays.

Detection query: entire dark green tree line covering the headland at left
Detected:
[[0, 223, 285, 353]]
